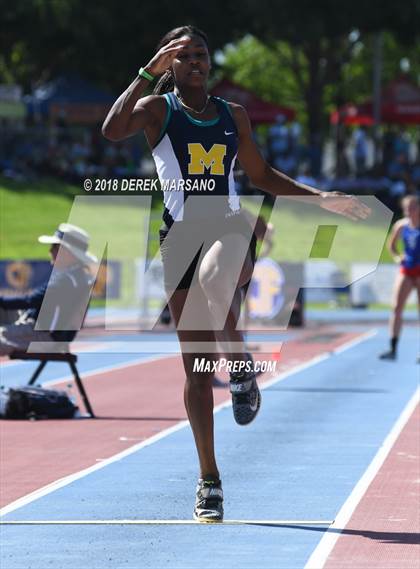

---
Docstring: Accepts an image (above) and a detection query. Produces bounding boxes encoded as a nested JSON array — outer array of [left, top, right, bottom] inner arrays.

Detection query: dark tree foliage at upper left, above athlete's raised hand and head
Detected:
[[0, 0, 253, 91]]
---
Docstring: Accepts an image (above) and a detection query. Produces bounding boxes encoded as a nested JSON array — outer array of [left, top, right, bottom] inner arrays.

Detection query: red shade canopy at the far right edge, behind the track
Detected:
[[331, 77, 420, 125]]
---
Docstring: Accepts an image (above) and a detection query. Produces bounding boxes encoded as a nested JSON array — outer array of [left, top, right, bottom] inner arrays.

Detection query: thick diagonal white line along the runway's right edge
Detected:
[[304, 388, 420, 569]]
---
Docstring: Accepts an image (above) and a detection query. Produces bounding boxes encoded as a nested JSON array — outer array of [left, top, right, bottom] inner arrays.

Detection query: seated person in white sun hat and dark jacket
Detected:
[[0, 223, 97, 355]]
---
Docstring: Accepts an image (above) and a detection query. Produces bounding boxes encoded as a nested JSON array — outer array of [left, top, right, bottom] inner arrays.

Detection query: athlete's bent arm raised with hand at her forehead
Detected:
[[102, 39, 185, 146]]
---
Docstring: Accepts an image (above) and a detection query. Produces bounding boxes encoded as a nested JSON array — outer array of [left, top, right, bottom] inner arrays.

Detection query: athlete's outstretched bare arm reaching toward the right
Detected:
[[230, 103, 370, 220]]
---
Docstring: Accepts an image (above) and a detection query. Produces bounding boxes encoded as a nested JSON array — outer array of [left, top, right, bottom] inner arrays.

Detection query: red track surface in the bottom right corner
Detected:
[[325, 406, 420, 569]]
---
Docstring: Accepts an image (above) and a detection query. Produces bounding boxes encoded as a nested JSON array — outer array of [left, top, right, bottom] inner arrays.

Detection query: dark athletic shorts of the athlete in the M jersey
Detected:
[[159, 215, 257, 290]]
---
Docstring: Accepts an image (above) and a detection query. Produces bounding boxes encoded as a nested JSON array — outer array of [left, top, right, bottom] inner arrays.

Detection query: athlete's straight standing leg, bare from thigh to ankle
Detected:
[[169, 286, 219, 478]]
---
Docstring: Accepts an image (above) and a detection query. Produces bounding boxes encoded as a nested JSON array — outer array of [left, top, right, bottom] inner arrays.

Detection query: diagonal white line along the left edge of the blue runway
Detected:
[[0, 326, 374, 517]]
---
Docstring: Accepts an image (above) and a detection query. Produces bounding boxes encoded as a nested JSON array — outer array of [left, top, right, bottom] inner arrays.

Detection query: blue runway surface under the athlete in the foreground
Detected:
[[1, 328, 419, 569]]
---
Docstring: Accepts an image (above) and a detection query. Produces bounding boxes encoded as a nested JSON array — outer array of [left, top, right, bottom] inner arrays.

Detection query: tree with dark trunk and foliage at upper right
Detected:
[[238, 0, 420, 175]]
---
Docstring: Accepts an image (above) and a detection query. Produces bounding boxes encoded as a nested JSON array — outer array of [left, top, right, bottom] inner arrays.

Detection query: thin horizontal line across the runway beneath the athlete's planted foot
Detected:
[[0, 520, 334, 526]]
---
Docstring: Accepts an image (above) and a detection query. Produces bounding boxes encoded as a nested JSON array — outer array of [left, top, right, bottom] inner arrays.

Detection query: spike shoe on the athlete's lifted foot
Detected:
[[229, 354, 261, 425]]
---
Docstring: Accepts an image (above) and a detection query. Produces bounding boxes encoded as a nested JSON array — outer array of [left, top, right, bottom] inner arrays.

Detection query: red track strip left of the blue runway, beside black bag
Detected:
[[0, 329, 358, 506]]
